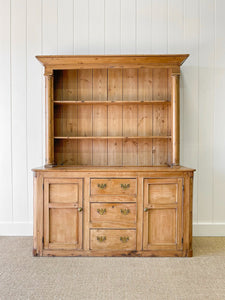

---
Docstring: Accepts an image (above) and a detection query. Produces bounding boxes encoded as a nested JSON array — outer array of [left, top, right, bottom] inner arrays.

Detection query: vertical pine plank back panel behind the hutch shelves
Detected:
[[54, 68, 172, 166]]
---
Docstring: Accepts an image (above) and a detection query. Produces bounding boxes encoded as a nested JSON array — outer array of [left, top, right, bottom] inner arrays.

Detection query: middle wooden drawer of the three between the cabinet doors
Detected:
[[91, 203, 136, 227]]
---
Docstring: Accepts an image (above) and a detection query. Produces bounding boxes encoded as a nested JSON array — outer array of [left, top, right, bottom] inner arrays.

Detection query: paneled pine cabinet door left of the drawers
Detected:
[[44, 178, 83, 249]]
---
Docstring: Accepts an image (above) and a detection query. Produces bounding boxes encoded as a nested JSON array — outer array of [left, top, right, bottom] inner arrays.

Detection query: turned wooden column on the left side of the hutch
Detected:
[[45, 74, 54, 166]]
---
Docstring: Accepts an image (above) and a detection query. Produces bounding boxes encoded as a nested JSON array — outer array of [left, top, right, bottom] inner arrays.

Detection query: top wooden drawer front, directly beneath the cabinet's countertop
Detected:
[[91, 178, 137, 196]]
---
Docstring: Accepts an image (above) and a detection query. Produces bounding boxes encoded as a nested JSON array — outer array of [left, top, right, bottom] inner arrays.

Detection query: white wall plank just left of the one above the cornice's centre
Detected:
[[89, 0, 105, 54]]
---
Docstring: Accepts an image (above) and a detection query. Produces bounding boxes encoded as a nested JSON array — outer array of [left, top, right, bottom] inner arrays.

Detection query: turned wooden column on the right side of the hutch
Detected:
[[171, 73, 180, 166]]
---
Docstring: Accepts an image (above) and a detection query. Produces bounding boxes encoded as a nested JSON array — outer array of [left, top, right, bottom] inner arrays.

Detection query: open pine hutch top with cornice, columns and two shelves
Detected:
[[36, 54, 189, 168]]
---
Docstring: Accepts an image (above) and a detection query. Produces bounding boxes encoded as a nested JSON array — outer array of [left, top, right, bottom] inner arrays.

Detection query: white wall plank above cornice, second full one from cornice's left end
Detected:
[[57, 0, 74, 55]]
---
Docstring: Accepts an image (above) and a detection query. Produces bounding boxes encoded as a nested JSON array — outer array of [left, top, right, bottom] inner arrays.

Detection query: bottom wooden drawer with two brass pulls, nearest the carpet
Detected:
[[90, 229, 136, 250]]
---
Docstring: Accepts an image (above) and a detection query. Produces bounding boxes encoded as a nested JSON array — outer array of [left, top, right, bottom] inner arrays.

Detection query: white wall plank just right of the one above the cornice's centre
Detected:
[[121, 0, 136, 54]]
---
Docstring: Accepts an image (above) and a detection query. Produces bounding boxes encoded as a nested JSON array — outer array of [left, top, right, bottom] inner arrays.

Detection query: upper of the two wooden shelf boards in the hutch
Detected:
[[54, 100, 170, 105]]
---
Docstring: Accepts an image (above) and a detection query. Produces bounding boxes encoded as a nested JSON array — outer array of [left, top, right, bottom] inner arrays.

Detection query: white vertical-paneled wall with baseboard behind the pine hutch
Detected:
[[0, 0, 225, 235]]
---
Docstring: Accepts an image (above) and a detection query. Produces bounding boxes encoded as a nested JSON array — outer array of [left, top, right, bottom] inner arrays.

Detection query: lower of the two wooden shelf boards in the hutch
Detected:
[[54, 136, 171, 140]]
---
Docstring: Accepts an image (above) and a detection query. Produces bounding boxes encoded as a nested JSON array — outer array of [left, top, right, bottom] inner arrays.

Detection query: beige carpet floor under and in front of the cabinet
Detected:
[[0, 237, 225, 300]]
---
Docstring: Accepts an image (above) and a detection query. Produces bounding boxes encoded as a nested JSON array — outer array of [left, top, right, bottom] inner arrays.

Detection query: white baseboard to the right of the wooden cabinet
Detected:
[[193, 223, 225, 236]]
